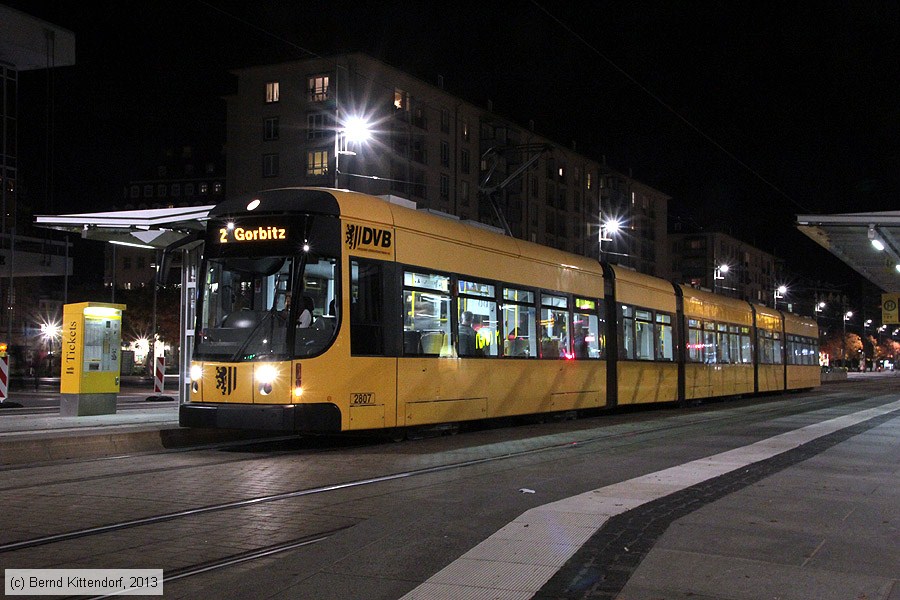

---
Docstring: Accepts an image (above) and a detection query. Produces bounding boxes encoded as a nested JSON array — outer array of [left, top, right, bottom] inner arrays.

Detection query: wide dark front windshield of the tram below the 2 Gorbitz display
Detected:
[[195, 254, 337, 362]]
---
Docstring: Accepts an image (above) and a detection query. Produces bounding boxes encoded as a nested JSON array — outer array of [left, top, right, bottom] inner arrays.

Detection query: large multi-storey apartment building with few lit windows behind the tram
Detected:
[[226, 53, 669, 278]]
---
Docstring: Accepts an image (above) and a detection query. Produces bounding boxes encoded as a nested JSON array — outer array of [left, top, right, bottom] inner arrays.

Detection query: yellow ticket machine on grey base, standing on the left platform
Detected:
[[59, 302, 125, 417]]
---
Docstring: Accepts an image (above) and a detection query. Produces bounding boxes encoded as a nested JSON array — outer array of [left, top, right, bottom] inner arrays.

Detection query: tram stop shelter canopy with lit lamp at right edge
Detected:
[[797, 211, 900, 292]]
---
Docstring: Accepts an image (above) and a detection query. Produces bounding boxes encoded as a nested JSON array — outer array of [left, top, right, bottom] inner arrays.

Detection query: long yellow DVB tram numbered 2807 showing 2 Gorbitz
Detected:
[[180, 188, 819, 432]]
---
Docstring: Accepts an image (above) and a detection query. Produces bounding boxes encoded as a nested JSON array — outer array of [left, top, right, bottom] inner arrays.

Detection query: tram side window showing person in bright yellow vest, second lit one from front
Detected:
[[457, 279, 500, 356]]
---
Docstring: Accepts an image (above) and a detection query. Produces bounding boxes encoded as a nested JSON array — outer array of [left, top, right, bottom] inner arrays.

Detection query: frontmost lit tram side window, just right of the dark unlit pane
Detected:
[[403, 271, 453, 357]]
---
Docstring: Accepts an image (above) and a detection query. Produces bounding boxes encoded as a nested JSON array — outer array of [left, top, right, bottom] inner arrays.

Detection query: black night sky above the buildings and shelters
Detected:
[[4, 0, 900, 296]]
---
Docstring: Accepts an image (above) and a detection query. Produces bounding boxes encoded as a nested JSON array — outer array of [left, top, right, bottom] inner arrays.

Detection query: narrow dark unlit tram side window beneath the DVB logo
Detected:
[[350, 260, 385, 356]]
